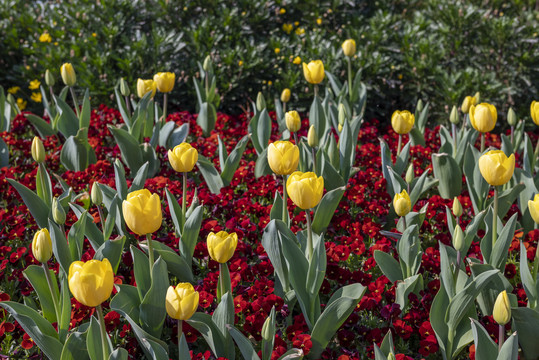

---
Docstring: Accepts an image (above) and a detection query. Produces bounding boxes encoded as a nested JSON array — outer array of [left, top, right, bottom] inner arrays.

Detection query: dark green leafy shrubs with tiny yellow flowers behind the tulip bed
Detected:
[[0, 0, 539, 123]]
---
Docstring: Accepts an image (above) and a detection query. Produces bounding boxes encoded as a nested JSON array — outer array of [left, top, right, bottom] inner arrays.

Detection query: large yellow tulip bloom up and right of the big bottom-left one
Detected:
[[122, 189, 163, 235]]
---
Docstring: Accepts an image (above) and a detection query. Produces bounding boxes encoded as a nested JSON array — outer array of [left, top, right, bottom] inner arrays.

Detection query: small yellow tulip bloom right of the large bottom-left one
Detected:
[[165, 283, 199, 320]]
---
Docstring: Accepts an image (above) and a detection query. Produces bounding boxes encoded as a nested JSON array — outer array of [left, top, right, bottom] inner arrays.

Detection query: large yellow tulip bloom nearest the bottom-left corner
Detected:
[[68, 258, 114, 307]]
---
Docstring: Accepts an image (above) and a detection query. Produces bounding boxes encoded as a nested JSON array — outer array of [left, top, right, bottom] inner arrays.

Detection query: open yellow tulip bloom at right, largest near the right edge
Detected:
[[479, 150, 515, 186]]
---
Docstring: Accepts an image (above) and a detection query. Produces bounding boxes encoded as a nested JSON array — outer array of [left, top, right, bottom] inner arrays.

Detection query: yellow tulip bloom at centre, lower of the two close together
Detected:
[[286, 171, 324, 210]]
